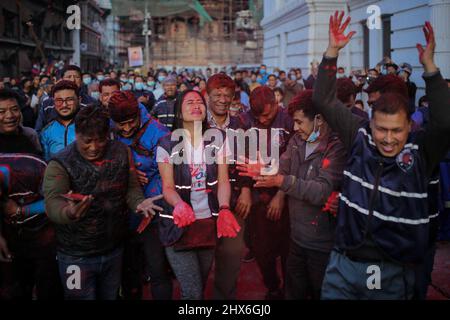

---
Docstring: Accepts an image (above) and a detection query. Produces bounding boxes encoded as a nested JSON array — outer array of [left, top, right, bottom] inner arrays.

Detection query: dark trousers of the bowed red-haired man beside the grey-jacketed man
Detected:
[[249, 202, 289, 292]]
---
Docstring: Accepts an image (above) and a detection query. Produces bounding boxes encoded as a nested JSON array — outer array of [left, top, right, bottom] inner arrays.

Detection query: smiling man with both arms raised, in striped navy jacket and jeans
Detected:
[[313, 12, 450, 299]]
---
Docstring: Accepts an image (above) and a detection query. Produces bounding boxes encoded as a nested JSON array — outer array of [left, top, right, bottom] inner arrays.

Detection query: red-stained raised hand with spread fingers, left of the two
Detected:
[[325, 11, 356, 57]]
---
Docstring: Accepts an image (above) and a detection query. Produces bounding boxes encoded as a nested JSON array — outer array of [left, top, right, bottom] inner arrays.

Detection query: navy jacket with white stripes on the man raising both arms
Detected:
[[313, 57, 450, 264]]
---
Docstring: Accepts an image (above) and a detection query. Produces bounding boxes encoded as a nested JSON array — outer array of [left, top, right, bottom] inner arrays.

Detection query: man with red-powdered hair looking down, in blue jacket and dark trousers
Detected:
[[108, 91, 172, 300]]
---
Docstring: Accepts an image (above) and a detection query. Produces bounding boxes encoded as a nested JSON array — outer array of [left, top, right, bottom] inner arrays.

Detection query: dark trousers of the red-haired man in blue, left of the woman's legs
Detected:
[[122, 224, 172, 300]]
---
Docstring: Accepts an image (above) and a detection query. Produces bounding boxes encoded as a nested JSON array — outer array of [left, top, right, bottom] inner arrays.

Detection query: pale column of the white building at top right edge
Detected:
[[428, 0, 450, 78]]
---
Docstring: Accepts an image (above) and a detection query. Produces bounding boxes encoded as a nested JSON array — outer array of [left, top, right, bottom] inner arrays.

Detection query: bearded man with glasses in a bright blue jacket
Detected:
[[40, 80, 80, 161]]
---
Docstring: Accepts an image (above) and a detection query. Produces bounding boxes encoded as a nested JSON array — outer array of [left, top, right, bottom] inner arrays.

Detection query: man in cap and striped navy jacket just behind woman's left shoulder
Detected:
[[152, 76, 177, 131]]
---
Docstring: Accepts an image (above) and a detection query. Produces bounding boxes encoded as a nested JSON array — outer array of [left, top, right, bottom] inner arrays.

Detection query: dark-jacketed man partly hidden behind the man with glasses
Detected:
[[35, 65, 96, 132]]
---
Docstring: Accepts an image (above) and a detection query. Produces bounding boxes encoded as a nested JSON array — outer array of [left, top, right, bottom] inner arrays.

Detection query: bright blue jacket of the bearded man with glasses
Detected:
[[39, 120, 75, 161]]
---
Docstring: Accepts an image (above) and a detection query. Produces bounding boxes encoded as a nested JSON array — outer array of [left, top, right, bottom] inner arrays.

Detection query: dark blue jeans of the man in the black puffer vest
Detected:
[[58, 247, 123, 300]]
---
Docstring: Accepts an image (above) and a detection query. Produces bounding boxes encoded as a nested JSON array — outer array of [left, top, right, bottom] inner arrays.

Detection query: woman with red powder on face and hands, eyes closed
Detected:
[[157, 90, 240, 300]]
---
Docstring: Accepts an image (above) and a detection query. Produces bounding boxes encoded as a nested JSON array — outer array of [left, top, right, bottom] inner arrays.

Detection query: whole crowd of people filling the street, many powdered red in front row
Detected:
[[0, 12, 450, 300]]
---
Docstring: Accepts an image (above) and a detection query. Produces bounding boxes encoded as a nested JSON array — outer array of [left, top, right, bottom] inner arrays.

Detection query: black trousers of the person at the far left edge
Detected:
[[0, 223, 63, 300]]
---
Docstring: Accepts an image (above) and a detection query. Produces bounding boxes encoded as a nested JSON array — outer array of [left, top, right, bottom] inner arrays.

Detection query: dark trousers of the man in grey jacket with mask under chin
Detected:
[[286, 241, 330, 300]]
